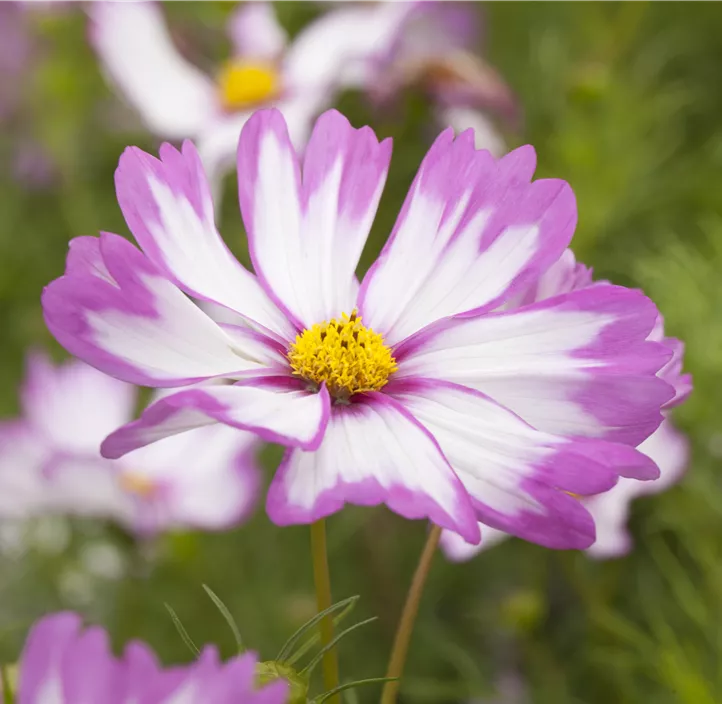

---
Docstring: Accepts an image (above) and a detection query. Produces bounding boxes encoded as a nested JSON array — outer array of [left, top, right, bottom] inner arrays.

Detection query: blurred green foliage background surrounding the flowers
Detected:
[[0, 0, 722, 704]]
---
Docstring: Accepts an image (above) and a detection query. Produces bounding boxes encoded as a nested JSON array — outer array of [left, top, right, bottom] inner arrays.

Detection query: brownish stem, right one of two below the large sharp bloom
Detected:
[[381, 525, 441, 704]]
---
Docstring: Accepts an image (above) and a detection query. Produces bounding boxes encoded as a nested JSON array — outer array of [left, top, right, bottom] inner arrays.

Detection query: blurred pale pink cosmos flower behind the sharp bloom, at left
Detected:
[[0, 354, 258, 533]]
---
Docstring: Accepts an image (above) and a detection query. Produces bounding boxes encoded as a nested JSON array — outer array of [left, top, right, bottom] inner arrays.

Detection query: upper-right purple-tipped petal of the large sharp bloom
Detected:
[[359, 135, 577, 344]]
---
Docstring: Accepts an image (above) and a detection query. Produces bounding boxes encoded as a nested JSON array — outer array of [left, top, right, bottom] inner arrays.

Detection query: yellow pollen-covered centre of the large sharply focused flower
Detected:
[[288, 311, 396, 401]]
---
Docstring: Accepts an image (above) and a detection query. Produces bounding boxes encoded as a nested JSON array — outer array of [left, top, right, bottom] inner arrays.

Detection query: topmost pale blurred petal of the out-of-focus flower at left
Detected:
[[22, 352, 137, 453]]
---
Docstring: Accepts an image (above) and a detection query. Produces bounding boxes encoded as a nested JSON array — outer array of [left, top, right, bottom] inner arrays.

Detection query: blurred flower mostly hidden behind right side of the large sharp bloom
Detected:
[[441, 250, 692, 561]]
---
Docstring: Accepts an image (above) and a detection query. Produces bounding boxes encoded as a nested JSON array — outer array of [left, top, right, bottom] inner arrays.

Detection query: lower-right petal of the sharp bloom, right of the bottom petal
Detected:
[[389, 379, 646, 549]]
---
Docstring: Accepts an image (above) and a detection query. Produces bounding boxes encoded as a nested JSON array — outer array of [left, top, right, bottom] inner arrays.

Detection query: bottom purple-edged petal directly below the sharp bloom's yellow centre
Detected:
[[266, 392, 479, 541]]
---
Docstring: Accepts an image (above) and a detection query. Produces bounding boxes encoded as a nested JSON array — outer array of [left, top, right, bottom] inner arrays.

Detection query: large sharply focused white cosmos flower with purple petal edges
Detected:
[[43, 110, 672, 547]]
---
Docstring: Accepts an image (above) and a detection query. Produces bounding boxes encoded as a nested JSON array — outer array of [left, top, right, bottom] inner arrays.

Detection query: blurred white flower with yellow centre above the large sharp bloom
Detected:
[[88, 0, 414, 190]]
